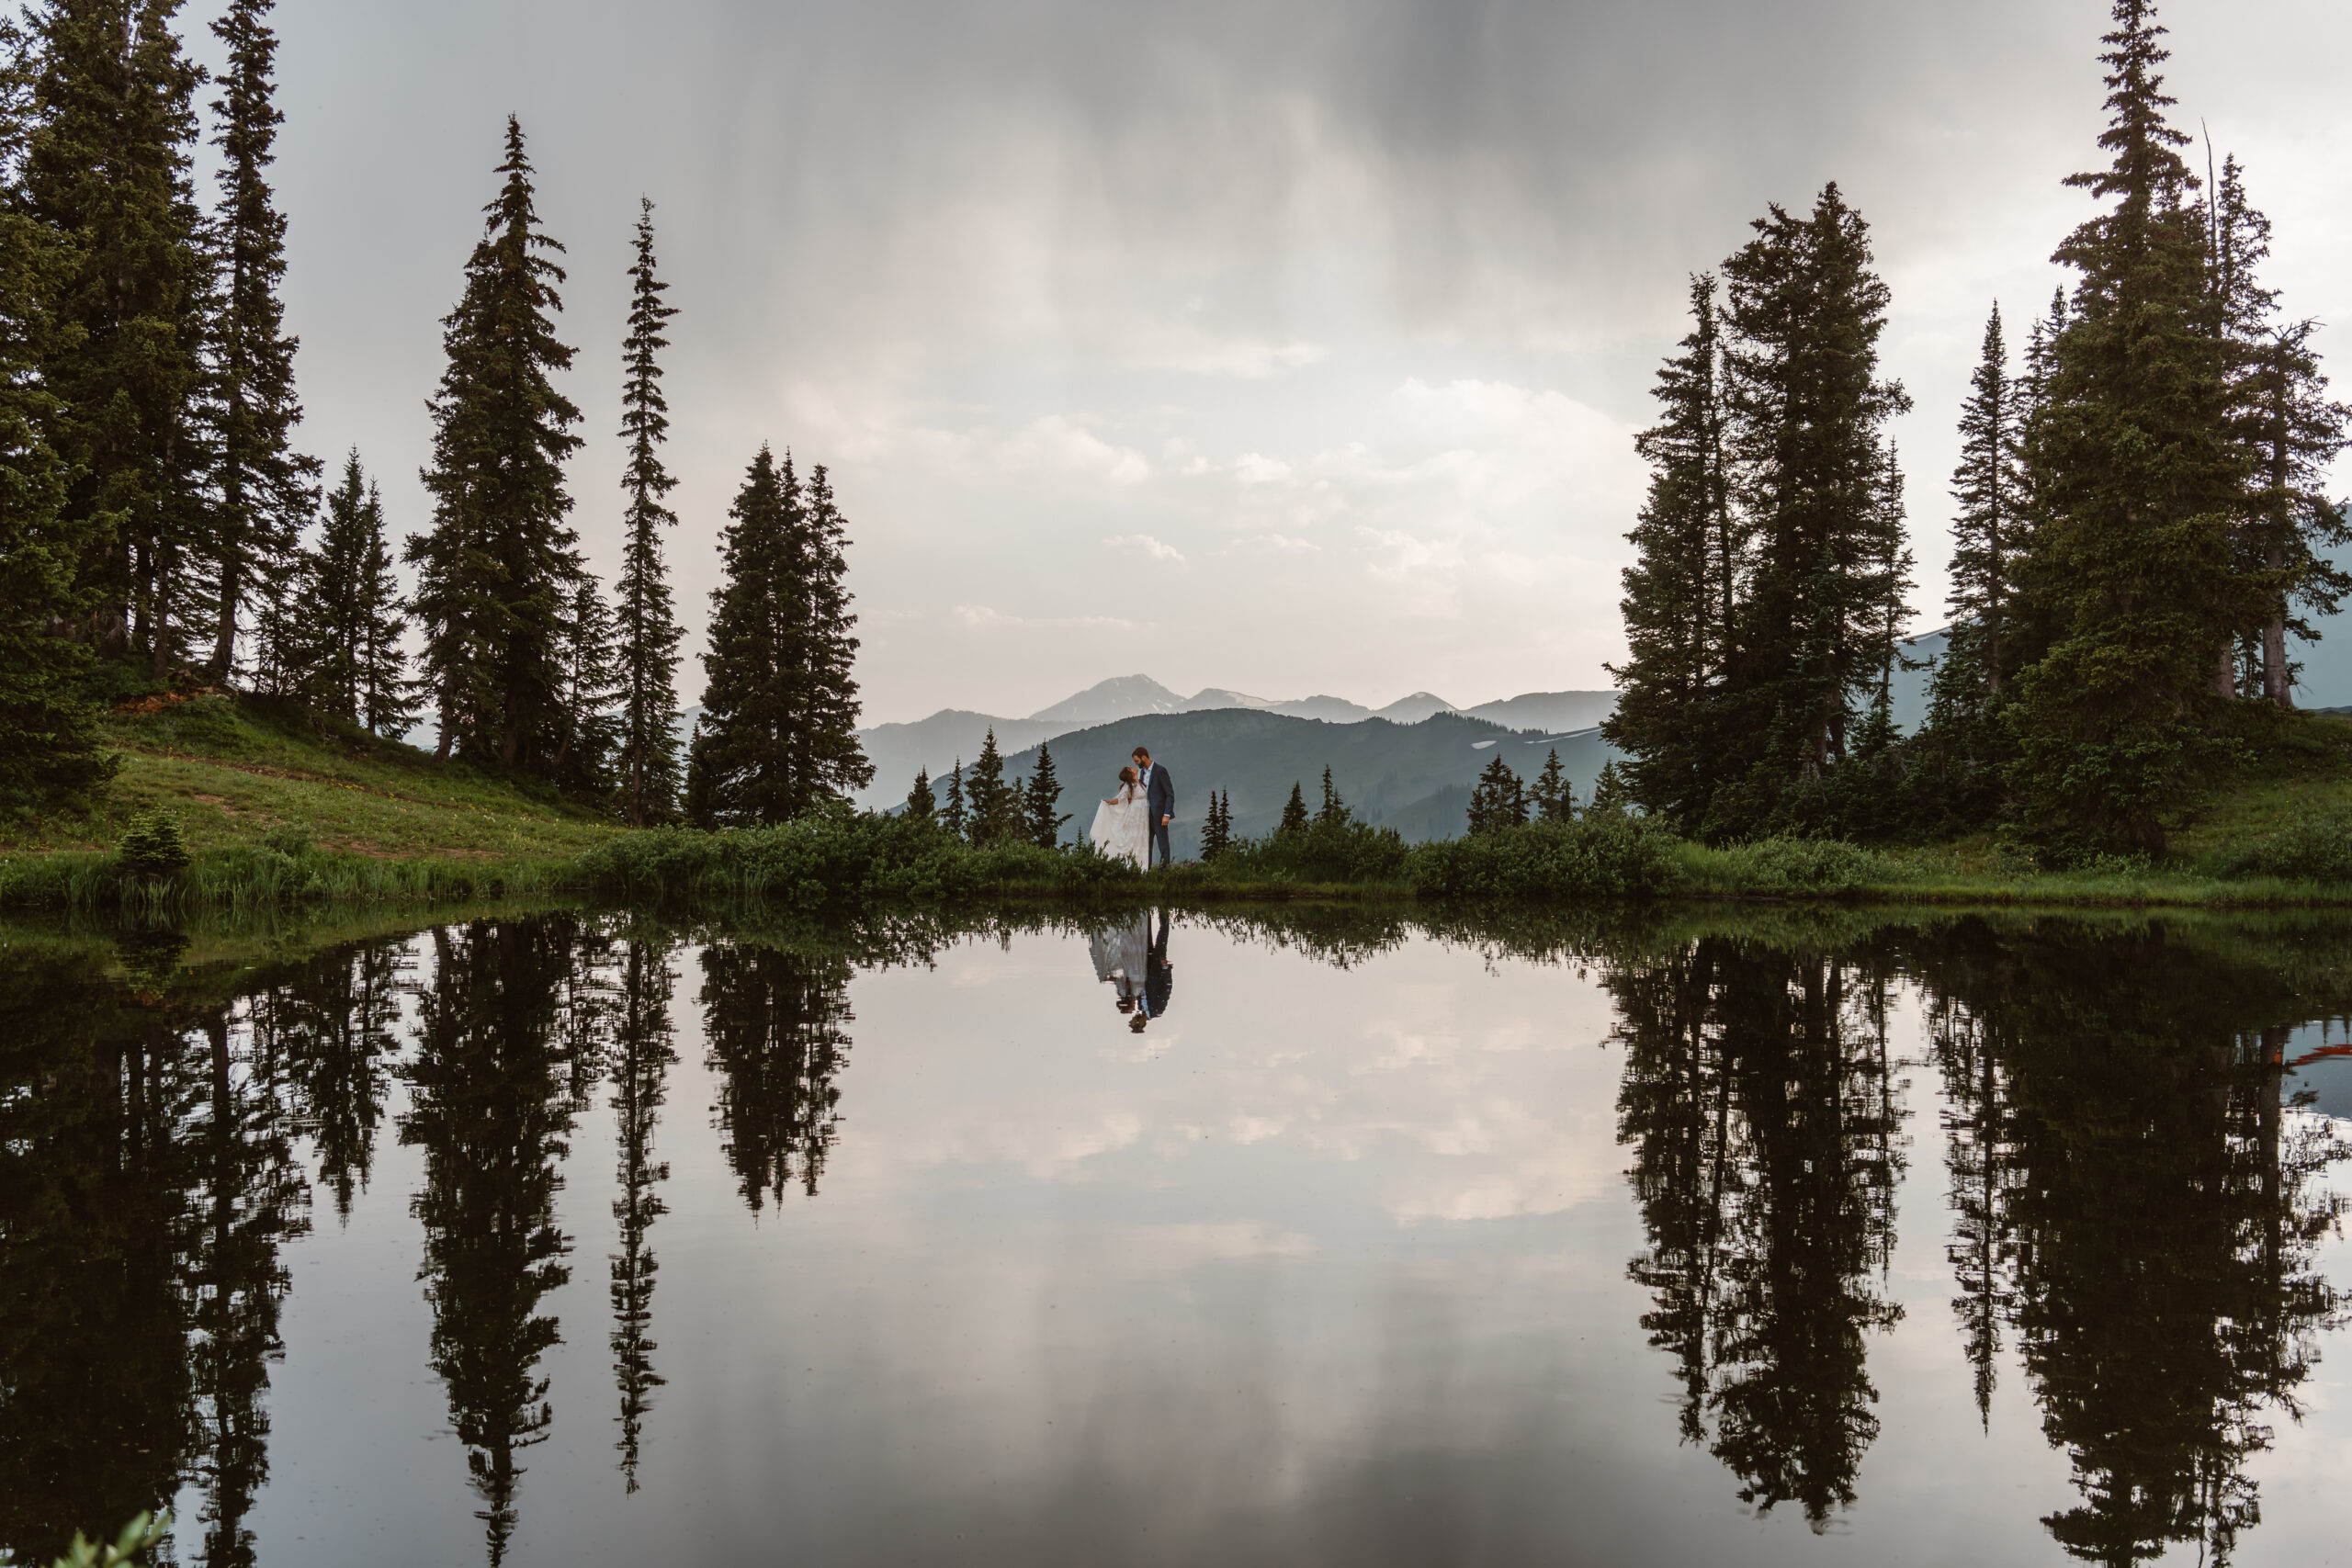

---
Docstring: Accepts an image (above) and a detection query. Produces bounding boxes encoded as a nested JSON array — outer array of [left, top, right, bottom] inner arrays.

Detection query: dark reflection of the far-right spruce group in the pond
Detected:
[[1924, 921, 2347, 1563]]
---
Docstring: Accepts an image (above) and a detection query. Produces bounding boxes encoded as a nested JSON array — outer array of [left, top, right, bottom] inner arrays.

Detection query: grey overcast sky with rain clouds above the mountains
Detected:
[[229, 0, 2352, 722]]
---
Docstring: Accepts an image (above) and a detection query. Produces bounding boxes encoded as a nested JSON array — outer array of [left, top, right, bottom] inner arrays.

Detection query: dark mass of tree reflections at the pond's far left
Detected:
[[0, 931, 418, 1568]]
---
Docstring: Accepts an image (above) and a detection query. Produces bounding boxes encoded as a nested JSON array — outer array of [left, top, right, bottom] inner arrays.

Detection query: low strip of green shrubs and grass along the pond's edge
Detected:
[[14, 807, 2352, 915]]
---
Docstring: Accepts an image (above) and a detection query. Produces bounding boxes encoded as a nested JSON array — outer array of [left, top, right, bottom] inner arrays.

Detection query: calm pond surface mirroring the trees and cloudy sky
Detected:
[[14, 912, 2352, 1568]]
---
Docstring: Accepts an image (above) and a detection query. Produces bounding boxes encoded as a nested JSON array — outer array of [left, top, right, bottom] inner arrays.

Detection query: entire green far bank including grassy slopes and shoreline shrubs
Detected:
[[14, 696, 2352, 917]]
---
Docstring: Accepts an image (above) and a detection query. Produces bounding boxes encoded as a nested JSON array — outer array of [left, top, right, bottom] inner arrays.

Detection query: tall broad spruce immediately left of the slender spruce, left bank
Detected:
[[409, 118, 581, 776]]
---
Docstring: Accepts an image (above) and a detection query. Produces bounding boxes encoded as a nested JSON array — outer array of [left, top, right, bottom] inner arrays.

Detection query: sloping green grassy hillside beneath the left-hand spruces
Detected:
[[0, 696, 616, 863]]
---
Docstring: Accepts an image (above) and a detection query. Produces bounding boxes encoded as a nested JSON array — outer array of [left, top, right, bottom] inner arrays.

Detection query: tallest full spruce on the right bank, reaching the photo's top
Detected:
[[2007, 0, 2265, 853]]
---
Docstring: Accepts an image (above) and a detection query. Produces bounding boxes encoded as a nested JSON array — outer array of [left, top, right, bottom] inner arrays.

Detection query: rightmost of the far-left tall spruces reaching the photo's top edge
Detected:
[[209, 0, 318, 680]]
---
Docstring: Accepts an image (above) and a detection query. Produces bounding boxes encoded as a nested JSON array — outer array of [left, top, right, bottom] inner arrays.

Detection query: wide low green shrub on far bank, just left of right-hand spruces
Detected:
[[1411, 811, 1677, 900]]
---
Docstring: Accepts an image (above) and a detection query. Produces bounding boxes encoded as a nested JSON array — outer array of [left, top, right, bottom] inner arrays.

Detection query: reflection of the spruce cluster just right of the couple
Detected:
[[1606, 938, 1903, 1530]]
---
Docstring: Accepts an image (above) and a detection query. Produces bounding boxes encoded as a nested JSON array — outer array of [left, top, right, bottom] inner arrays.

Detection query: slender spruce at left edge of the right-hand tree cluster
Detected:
[[1601, 273, 1743, 820]]
